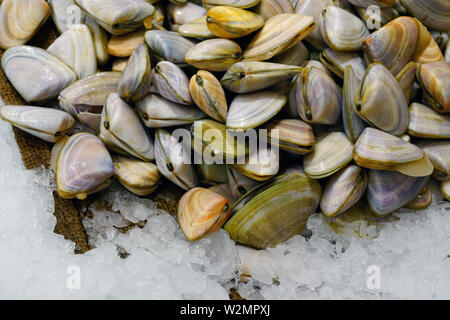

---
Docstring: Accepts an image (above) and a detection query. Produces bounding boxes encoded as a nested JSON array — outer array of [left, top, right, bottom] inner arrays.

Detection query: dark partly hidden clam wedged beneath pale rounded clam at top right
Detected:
[[320, 48, 366, 80]]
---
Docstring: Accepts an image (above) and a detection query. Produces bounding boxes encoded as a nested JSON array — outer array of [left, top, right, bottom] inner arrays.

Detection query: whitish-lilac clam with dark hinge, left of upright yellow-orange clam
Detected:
[[152, 61, 193, 105]]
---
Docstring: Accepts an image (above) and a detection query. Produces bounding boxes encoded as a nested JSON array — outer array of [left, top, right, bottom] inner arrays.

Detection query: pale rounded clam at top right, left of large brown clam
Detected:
[[321, 6, 369, 51]]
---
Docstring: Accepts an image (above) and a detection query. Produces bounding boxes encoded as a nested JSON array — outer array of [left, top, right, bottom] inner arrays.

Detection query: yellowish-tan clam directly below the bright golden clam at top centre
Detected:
[[184, 39, 242, 71]]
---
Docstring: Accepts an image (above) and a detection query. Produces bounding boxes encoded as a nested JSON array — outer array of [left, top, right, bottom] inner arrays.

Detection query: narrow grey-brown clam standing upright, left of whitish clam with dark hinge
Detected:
[[119, 43, 152, 101]]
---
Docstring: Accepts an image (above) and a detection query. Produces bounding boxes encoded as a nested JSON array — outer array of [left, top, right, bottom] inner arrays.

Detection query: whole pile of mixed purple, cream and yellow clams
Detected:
[[0, 0, 450, 248]]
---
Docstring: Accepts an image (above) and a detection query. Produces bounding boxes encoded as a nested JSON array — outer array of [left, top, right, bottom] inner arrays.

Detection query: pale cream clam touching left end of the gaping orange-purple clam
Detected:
[[303, 132, 353, 179]]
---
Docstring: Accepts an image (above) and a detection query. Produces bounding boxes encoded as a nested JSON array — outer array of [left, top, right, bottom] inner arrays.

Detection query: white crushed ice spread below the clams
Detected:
[[0, 118, 450, 299]]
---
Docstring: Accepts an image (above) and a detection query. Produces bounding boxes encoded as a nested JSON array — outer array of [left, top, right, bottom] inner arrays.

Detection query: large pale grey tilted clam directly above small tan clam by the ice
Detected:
[[99, 93, 155, 161]]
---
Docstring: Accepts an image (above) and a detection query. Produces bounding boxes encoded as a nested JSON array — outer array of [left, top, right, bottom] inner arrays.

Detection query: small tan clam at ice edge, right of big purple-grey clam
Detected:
[[112, 155, 161, 197]]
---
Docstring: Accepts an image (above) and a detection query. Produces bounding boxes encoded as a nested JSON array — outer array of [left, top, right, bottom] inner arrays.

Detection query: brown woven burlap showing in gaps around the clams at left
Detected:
[[0, 18, 181, 253]]
